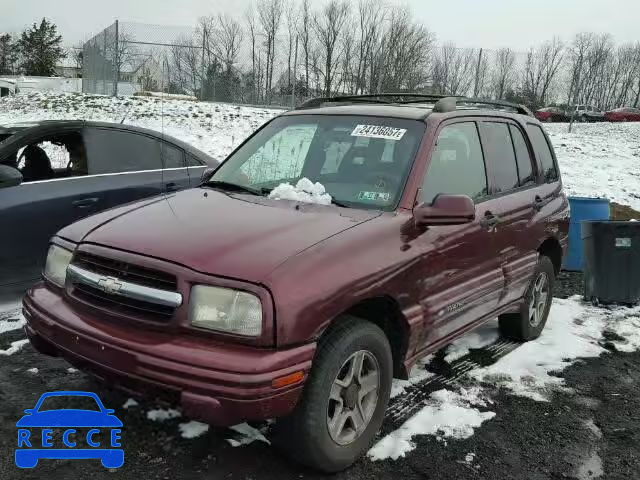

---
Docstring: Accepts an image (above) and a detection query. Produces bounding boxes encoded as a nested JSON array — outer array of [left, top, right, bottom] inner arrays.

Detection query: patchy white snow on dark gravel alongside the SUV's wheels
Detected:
[[369, 297, 640, 460]]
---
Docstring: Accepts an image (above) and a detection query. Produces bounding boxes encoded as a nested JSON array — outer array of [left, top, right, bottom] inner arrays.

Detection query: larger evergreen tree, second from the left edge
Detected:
[[18, 18, 66, 77]]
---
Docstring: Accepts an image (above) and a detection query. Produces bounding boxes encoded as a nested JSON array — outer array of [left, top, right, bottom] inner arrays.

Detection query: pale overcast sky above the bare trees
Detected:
[[0, 0, 640, 50]]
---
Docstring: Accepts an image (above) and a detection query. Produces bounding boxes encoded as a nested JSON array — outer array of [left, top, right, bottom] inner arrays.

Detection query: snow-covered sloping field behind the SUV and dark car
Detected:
[[0, 92, 640, 210]]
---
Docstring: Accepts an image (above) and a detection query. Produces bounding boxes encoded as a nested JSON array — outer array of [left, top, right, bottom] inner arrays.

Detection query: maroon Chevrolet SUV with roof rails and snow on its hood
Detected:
[[24, 96, 569, 471]]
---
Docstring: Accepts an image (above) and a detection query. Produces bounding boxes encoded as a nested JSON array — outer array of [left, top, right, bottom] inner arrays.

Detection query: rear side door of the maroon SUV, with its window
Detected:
[[480, 118, 540, 305]]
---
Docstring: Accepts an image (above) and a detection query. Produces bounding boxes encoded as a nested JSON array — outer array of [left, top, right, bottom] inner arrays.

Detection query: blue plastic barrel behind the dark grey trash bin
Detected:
[[564, 197, 610, 272]]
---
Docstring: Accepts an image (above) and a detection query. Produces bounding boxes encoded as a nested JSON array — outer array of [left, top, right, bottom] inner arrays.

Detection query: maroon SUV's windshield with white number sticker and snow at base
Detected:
[[211, 115, 426, 210]]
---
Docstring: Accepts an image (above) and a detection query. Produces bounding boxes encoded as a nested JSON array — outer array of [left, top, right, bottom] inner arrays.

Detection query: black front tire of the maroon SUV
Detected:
[[274, 316, 393, 473]]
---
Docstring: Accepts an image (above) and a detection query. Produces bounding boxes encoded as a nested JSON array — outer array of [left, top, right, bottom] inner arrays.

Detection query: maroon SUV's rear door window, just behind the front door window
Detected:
[[482, 122, 519, 193]]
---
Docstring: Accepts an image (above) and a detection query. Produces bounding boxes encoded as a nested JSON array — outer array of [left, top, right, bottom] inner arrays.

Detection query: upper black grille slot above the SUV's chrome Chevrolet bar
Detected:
[[73, 252, 178, 291]]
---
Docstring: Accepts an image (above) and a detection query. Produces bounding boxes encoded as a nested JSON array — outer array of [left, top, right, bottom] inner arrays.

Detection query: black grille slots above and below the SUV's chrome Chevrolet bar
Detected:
[[69, 252, 177, 323]]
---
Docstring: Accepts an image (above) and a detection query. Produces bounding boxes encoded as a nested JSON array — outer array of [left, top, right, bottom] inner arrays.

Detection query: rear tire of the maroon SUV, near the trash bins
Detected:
[[498, 255, 555, 342]]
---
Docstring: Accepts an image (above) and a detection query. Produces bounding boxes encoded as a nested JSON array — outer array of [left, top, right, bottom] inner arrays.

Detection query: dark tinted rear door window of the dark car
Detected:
[[85, 128, 162, 175]]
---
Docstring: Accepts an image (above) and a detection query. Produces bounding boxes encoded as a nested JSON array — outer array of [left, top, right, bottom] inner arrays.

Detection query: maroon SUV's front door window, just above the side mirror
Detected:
[[421, 122, 487, 204]]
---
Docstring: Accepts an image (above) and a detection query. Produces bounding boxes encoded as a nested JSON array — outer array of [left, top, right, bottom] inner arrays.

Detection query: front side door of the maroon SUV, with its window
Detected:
[[417, 119, 504, 347]]
